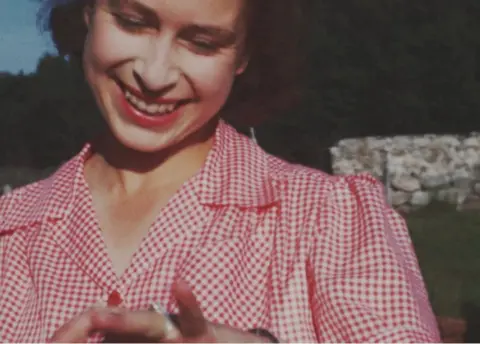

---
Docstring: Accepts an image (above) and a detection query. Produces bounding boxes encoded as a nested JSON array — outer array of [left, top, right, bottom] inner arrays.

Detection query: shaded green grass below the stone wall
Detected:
[[406, 203, 480, 317]]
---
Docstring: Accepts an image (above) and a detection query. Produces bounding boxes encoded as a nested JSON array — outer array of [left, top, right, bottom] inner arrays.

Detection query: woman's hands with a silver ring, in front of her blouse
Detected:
[[51, 282, 274, 343]]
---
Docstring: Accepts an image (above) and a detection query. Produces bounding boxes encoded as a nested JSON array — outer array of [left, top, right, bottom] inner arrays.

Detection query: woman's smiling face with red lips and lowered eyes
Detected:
[[84, 0, 245, 152]]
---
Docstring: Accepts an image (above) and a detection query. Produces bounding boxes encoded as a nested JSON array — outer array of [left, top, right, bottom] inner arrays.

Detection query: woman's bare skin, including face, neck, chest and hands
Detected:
[[51, 0, 270, 342]]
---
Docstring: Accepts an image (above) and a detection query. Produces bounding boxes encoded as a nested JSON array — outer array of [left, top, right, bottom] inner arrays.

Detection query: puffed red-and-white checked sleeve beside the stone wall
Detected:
[[310, 175, 440, 343]]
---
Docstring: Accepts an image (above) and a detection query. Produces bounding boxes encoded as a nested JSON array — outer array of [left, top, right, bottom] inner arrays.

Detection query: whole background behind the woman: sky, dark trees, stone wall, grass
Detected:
[[0, 0, 480, 342]]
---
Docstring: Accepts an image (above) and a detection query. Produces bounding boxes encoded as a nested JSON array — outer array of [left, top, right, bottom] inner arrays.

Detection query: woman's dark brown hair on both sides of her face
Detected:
[[38, 0, 306, 125]]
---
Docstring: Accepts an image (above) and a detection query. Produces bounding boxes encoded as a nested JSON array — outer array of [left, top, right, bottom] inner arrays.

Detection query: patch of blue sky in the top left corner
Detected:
[[0, 0, 53, 73]]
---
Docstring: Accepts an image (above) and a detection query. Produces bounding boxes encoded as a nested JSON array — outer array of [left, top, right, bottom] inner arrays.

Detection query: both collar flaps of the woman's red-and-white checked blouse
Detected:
[[0, 121, 277, 234]]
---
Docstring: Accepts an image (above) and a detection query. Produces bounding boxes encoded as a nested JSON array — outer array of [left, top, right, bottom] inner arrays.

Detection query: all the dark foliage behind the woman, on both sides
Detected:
[[0, 0, 480, 170]]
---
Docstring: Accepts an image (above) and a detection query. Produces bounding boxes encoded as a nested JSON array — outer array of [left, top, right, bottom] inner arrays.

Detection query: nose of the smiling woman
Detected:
[[134, 38, 180, 92]]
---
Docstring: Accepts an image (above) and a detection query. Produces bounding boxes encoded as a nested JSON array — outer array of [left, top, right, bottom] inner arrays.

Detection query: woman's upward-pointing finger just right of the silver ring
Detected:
[[172, 281, 209, 338]]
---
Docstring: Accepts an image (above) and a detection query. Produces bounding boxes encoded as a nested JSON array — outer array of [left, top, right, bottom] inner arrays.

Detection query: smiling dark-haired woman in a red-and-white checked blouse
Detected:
[[0, 0, 439, 342]]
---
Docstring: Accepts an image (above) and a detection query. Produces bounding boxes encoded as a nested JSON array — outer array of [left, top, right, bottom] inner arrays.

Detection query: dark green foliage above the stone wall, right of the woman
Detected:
[[253, 0, 480, 169]]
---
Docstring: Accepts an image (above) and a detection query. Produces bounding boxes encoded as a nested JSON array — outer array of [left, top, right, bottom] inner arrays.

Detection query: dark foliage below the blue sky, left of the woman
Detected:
[[0, 55, 102, 168]]
